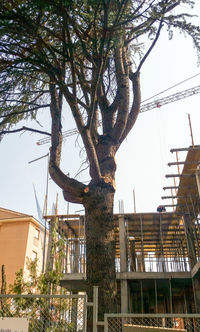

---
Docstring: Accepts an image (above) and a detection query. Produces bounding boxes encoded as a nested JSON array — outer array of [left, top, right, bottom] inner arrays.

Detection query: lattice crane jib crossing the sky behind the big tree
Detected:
[[37, 85, 200, 145]]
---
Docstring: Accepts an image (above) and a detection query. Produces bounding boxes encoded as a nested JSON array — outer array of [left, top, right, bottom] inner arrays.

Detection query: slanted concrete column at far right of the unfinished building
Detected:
[[184, 214, 197, 270]]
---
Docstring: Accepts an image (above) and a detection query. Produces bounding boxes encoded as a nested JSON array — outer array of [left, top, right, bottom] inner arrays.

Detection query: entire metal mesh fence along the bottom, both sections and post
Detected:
[[0, 287, 200, 332]]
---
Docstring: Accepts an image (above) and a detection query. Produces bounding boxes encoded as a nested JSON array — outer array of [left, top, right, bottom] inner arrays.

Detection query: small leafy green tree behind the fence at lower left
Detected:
[[0, 260, 78, 332]]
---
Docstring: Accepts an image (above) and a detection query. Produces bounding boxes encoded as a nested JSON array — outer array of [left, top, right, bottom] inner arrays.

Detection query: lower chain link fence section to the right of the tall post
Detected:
[[104, 314, 200, 332]]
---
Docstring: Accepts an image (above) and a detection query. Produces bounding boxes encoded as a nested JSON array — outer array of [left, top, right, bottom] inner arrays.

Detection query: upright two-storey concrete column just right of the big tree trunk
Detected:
[[119, 215, 128, 313]]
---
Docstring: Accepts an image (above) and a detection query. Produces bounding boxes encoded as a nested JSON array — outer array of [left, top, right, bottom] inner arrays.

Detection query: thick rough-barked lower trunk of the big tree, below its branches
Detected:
[[84, 182, 116, 330]]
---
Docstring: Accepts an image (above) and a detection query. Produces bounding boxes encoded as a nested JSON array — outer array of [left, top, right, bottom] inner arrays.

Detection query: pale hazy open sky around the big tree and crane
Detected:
[[0, 4, 200, 218]]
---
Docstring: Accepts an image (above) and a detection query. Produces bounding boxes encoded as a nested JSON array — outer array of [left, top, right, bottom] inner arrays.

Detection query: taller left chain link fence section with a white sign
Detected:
[[0, 295, 86, 332]]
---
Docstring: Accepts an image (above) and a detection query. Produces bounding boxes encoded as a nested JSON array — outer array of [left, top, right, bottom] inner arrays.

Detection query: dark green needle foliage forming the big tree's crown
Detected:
[[0, 0, 200, 135]]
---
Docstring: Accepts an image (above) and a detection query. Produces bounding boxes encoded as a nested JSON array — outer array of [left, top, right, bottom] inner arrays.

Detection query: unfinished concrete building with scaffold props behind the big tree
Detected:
[[46, 146, 200, 314]]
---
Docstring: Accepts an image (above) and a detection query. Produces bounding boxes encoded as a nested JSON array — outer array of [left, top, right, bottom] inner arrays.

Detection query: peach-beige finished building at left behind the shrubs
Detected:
[[0, 218, 48, 290]]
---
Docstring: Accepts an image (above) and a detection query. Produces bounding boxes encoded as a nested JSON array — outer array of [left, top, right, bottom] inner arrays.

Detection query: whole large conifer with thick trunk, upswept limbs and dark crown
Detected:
[[0, 0, 200, 322]]
